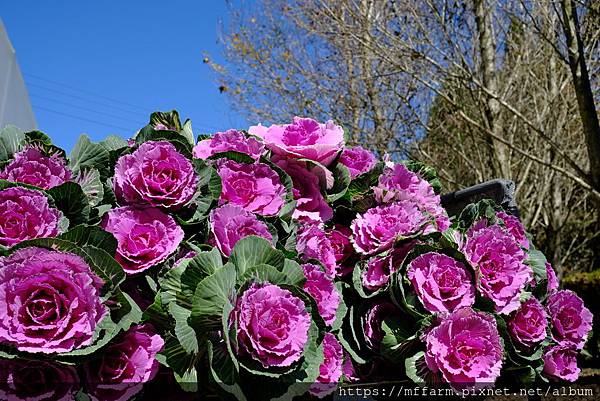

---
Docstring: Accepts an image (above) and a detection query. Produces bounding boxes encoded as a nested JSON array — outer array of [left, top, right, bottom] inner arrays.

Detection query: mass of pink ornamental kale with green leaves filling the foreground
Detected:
[[0, 111, 592, 401]]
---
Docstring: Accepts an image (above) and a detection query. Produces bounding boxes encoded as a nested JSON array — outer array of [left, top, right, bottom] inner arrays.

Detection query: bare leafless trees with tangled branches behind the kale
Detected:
[[208, 0, 600, 270]]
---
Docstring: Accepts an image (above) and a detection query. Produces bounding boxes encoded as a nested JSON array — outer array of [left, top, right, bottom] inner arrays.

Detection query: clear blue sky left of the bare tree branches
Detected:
[[0, 0, 246, 150]]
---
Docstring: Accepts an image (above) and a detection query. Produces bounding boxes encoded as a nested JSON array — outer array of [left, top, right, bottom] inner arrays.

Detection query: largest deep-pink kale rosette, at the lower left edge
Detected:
[[0, 247, 107, 354]]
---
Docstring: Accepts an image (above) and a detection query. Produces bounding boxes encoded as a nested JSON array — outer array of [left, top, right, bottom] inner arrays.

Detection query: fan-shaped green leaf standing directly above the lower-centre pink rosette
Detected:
[[229, 235, 285, 275]]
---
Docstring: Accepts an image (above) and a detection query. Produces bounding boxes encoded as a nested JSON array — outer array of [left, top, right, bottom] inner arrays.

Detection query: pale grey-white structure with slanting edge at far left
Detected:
[[0, 19, 36, 131]]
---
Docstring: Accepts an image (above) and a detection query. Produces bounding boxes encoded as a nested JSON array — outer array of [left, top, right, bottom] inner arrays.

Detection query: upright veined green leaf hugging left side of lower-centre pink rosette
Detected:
[[190, 263, 236, 332]]
